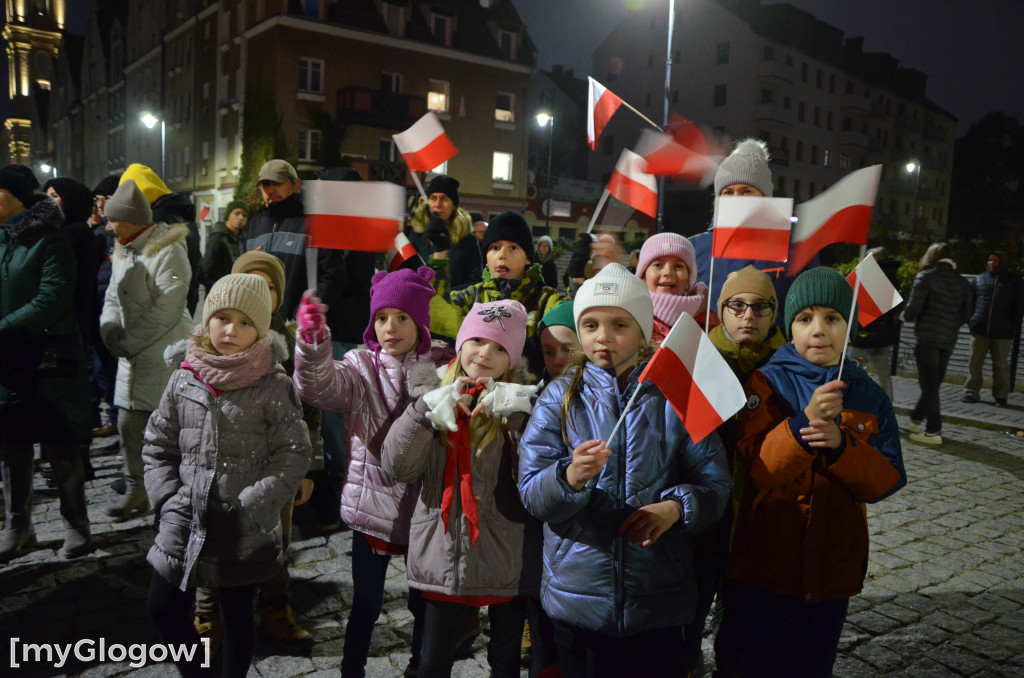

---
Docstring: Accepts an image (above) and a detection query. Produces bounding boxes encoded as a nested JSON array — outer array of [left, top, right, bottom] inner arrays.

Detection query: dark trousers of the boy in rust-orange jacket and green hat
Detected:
[[716, 579, 849, 678]]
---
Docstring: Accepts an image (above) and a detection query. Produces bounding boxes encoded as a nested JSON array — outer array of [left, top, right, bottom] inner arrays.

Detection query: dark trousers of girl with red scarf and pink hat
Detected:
[[419, 598, 526, 678]]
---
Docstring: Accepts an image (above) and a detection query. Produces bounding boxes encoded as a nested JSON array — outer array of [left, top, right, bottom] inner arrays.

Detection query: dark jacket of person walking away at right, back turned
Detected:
[[903, 259, 974, 346]]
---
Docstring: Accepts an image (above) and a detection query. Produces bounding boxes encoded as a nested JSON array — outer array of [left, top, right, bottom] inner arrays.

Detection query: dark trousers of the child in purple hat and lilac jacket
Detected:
[[341, 532, 424, 678]]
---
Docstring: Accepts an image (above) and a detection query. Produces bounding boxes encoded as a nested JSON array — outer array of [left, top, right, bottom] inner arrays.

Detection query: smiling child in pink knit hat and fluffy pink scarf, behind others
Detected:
[[637, 234, 717, 344]]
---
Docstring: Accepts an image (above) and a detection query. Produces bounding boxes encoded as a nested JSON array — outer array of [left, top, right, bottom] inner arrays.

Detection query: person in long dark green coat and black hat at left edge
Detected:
[[0, 174, 91, 563]]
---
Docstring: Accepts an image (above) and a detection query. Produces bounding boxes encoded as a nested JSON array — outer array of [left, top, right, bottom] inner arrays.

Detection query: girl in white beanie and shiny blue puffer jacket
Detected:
[[519, 263, 730, 677]]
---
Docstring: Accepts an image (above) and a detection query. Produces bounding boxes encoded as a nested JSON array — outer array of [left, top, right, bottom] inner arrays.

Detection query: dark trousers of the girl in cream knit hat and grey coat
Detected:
[[145, 573, 256, 678]]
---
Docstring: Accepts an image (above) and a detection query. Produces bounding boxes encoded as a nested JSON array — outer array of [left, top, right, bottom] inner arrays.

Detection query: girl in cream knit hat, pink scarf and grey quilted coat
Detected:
[[142, 273, 310, 676]]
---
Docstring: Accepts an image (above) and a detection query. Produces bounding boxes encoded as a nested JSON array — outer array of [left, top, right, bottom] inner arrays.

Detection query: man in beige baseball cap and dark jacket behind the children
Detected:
[[246, 158, 346, 329]]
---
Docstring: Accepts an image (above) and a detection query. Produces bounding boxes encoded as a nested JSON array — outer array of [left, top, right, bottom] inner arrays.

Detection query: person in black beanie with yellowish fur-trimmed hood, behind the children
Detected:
[[406, 174, 483, 290]]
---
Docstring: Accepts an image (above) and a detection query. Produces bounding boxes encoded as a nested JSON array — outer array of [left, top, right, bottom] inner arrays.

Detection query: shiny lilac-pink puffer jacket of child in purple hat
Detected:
[[294, 335, 454, 545]]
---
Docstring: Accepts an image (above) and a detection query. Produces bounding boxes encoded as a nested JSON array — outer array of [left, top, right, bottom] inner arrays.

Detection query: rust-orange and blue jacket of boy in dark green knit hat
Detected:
[[728, 344, 906, 602]]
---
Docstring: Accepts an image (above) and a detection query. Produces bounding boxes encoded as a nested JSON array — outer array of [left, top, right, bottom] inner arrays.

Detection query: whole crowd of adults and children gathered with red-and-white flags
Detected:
[[0, 133, 1021, 678]]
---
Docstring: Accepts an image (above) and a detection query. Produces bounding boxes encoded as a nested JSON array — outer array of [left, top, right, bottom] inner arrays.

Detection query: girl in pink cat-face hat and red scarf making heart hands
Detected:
[[383, 300, 540, 678]]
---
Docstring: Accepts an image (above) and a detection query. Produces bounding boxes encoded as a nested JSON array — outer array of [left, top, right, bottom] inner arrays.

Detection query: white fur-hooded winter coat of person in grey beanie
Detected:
[[99, 223, 191, 411]]
